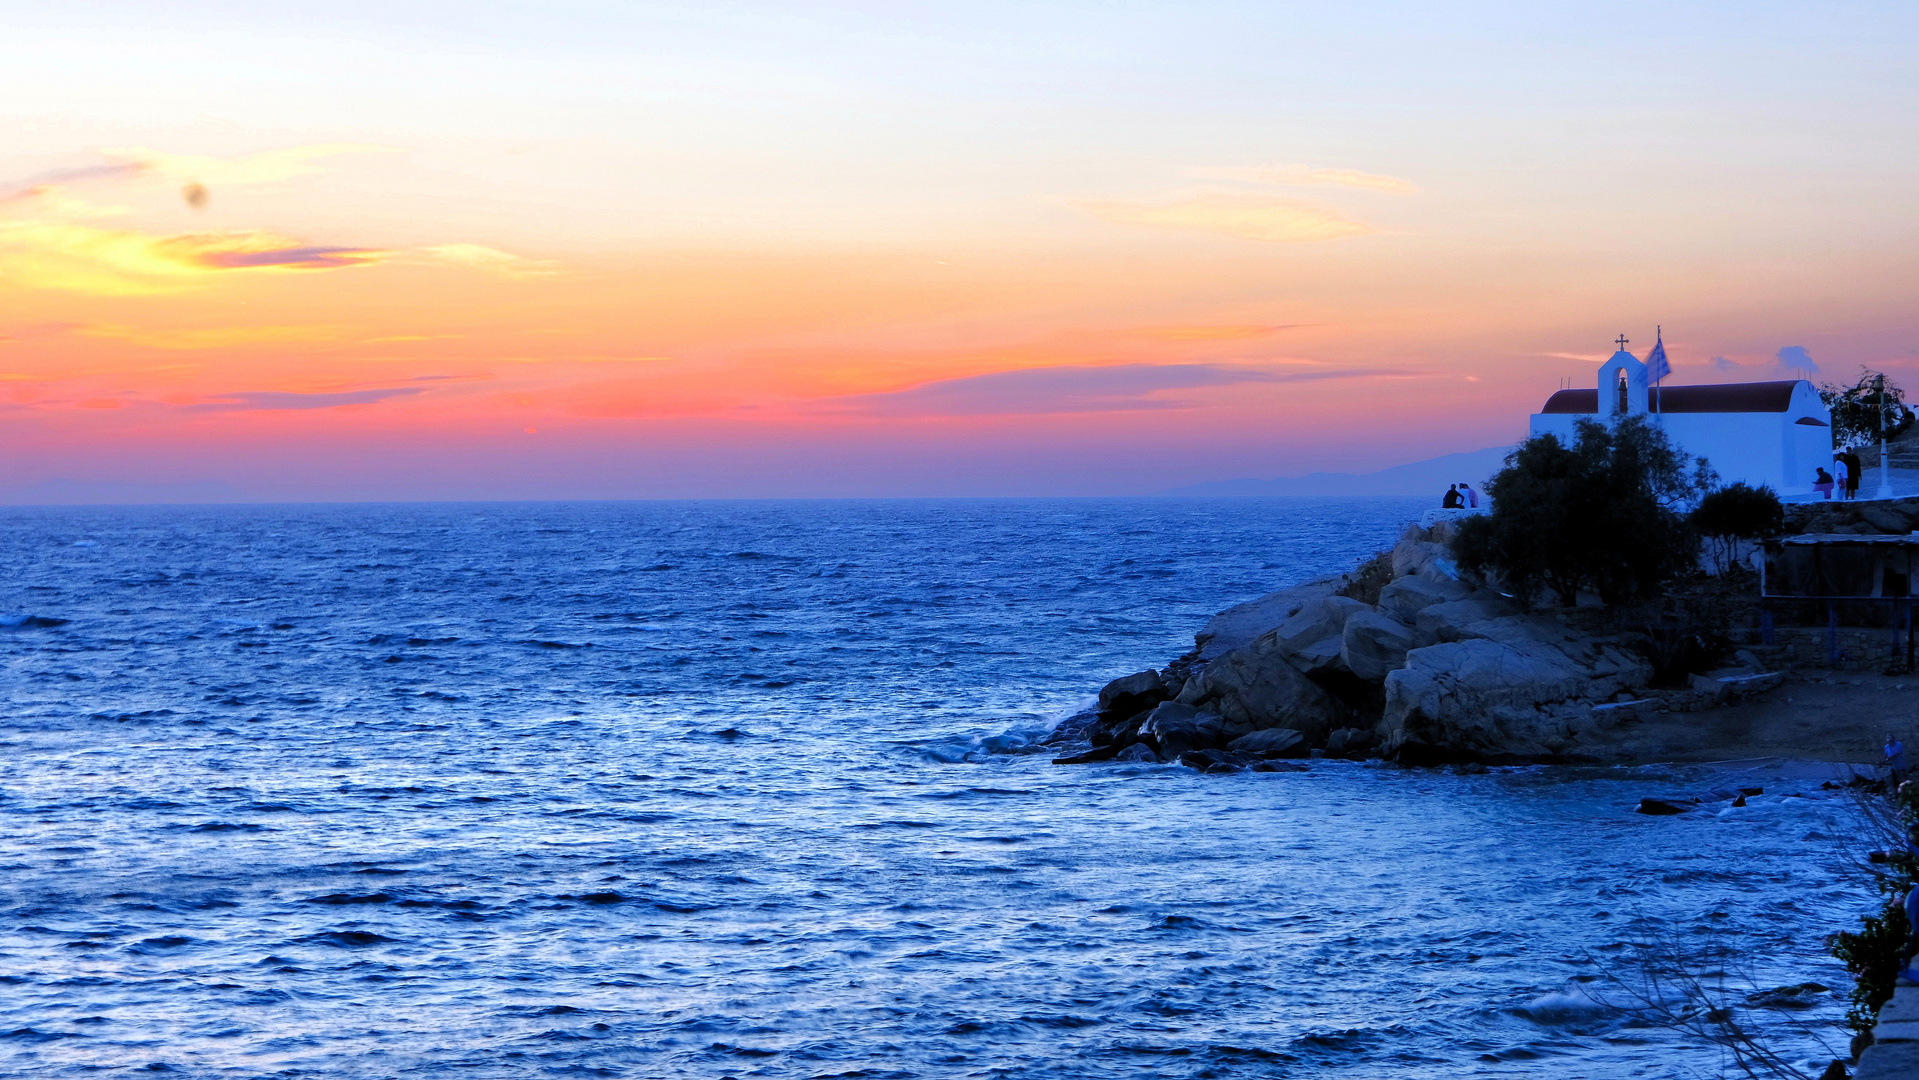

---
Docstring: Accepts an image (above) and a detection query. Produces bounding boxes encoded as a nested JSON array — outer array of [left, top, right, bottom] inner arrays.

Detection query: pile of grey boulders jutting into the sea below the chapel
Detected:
[[1050, 522, 1781, 771]]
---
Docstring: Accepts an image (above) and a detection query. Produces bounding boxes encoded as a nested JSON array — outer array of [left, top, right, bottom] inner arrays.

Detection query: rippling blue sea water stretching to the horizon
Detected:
[[0, 499, 1869, 1078]]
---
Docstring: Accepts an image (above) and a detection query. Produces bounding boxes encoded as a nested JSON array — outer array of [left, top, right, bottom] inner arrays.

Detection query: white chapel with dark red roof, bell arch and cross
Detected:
[[1531, 338, 1833, 495]]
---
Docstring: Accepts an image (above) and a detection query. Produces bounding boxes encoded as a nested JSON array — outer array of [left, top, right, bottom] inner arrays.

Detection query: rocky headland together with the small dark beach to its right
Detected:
[[1052, 499, 1919, 771]]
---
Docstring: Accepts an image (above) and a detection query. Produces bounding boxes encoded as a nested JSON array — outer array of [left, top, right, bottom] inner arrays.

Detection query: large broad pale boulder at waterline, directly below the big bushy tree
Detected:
[[1380, 621, 1652, 763]]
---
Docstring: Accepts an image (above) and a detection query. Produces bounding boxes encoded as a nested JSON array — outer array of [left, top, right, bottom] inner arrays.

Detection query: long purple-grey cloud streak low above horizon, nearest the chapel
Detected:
[[833, 364, 1410, 416]]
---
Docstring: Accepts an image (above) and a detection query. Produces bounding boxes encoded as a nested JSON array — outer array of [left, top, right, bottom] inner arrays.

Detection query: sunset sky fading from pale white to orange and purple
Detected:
[[0, 0, 1919, 503]]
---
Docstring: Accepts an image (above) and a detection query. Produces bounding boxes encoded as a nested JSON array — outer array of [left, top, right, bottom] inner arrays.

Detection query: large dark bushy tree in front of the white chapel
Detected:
[[1451, 416, 1716, 606]]
